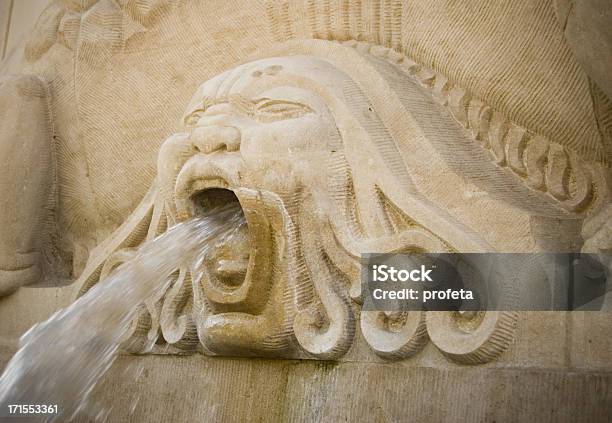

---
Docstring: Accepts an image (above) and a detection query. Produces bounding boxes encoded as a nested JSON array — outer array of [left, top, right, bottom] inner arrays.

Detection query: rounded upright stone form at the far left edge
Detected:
[[0, 76, 55, 295]]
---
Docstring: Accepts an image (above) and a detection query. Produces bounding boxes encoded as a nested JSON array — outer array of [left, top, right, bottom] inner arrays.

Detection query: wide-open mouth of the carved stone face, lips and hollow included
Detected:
[[174, 166, 284, 314]]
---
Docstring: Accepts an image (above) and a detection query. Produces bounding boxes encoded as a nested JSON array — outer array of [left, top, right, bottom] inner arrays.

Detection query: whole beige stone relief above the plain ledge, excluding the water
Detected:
[[0, 0, 612, 370]]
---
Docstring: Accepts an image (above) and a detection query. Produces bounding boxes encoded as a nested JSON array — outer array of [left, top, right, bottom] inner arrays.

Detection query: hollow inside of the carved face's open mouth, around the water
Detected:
[[190, 188, 251, 290]]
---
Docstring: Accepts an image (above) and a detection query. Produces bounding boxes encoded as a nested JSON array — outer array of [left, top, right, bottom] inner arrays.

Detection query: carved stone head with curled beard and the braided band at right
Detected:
[[68, 40, 607, 364]]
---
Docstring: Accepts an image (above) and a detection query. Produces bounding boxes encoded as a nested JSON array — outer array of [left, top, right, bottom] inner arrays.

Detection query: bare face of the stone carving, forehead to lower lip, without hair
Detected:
[[158, 58, 344, 349]]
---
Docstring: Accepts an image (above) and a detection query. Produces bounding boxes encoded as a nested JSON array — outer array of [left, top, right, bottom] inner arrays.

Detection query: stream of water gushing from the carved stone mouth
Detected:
[[0, 205, 245, 422]]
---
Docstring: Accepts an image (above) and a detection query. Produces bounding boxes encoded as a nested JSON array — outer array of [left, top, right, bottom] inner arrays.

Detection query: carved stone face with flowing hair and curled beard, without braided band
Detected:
[[81, 47, 532, 362]]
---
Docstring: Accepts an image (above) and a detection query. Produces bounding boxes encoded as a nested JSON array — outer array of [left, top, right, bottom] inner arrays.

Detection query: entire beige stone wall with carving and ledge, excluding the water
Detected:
[[0, 0, 612, 421]]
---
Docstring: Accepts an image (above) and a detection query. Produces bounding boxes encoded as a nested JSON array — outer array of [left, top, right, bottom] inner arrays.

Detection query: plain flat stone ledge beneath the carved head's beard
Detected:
[[69, 356, 612, 422]]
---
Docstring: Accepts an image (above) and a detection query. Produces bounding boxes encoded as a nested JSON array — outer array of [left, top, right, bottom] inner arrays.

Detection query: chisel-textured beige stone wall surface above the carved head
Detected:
[[0, 1, 609, 261]]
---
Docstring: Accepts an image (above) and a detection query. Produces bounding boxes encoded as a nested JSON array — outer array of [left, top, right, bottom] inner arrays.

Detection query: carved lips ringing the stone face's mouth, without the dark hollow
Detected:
[[175, 153, 283, 304]]
